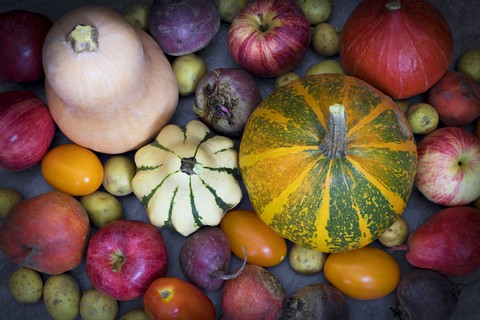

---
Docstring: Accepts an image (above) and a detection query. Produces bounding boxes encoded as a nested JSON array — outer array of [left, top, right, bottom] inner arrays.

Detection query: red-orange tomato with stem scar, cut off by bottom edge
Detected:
[[143, 277, 216, 320]]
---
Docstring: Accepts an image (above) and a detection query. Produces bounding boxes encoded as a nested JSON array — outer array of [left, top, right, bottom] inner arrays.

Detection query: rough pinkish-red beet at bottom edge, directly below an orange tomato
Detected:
[[221, 264, 285, 320]]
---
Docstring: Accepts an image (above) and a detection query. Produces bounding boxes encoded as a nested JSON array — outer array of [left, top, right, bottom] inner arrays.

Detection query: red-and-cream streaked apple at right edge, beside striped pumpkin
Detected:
[[415, 127, 480, 206]]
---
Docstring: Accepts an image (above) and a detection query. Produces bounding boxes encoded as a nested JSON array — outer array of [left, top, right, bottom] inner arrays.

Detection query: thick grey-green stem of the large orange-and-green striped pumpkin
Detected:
[[319, 103, 347, 159]]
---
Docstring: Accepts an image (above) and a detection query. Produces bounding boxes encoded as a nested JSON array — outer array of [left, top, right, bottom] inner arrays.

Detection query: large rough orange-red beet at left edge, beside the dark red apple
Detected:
[[0, 191, 90, 275]]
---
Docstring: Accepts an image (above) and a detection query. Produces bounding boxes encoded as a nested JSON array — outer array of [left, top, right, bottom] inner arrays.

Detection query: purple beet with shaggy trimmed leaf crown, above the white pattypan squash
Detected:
[[193, 68, 262, 137]]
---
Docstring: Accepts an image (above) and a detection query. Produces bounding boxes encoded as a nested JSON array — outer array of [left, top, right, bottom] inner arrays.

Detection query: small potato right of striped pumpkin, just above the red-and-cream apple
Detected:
[[406, 102, 439, 135]]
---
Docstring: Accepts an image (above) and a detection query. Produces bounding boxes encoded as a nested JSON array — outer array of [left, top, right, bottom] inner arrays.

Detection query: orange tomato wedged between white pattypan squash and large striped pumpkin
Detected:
[[219, 210, 287, 267]]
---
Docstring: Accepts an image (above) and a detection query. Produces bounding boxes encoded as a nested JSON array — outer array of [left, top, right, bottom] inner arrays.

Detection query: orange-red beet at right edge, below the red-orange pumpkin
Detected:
[[427, 71, 480, 127]]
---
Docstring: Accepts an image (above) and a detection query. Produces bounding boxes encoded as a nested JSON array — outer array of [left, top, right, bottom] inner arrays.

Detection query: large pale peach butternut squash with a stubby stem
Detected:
[[42, 5, 178, 154]]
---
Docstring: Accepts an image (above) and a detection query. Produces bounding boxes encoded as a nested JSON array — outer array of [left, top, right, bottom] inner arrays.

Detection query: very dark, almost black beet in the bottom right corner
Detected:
[[393, 269, 460, 320]]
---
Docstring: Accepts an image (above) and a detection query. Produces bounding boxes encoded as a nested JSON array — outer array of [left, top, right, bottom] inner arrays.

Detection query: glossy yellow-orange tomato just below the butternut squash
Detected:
[[40, 143, 103, 196]]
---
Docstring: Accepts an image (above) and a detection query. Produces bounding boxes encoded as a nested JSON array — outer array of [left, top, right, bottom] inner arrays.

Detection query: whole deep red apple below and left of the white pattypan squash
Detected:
[[86, 220, 168, 301]]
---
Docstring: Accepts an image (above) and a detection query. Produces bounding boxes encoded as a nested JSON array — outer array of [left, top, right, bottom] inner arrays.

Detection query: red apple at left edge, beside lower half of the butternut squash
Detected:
[[0, 90, 55, 171]]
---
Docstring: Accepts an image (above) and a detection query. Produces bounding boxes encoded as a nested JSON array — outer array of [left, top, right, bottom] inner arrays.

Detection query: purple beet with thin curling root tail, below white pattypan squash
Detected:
[[180, 227, 246, 291]]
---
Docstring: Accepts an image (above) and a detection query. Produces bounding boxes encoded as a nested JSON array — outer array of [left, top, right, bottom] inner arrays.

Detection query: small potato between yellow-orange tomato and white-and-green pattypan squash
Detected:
[[102, 155, 137, 196]]
